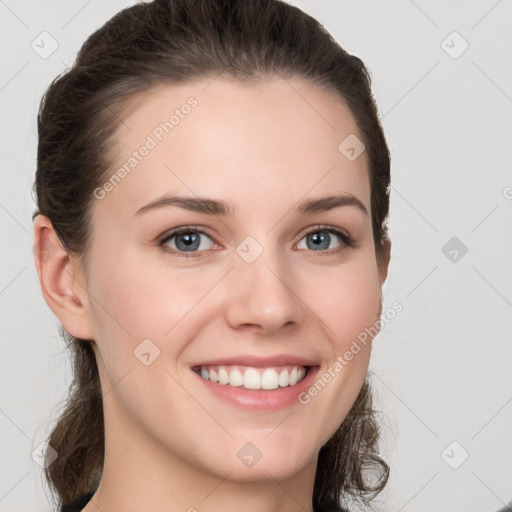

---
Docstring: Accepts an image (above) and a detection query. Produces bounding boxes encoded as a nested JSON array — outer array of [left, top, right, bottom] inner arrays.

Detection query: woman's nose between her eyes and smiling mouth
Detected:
[[226, 241, 305, 334]]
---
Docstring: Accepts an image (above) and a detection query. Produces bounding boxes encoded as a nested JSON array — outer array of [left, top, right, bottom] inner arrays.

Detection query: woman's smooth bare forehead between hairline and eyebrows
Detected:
[[95, 77, 370, 218]]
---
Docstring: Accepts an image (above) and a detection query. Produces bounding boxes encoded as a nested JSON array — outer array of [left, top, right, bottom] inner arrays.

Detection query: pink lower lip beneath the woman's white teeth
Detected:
[[192, 366, 320, 411]]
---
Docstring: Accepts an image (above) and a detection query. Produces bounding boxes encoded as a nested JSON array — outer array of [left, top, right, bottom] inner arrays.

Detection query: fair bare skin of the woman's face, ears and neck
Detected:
[[34, 78, 390, 512]]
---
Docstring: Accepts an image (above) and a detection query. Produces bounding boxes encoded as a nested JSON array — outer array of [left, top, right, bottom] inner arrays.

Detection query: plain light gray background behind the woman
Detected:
[[0, 0, 512, 512]]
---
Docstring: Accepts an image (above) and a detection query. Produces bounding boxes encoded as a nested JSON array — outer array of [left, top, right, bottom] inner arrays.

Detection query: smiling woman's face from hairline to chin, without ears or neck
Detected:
[[80, 78, 382, 481]]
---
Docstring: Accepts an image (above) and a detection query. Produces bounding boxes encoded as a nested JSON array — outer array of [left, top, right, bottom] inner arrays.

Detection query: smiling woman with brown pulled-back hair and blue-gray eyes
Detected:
[[34, 0, 390, 512]]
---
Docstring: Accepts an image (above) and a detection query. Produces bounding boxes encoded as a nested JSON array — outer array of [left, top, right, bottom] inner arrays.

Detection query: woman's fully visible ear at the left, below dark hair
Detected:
[[33, 214, 94, 340]]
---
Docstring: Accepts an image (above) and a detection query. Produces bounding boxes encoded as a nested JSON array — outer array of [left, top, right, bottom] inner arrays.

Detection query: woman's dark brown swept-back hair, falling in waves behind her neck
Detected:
[[33, 0, 390, 509]]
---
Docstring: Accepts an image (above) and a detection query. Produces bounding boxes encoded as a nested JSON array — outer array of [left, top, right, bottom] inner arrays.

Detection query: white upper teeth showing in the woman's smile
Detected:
[[200, 366, 306, 390]]
